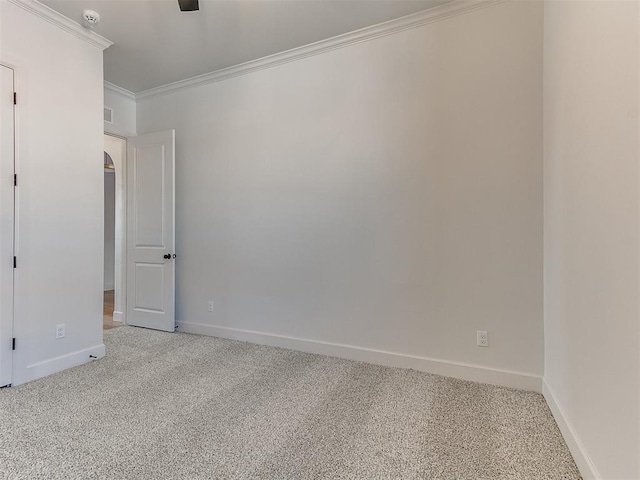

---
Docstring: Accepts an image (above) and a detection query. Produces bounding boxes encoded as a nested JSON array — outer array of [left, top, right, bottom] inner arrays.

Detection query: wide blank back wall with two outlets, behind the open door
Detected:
[[137, 2, 543, 388]]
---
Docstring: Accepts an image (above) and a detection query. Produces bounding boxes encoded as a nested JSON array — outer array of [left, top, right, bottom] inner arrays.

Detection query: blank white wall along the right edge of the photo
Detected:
[[544, 1, 640, 480]]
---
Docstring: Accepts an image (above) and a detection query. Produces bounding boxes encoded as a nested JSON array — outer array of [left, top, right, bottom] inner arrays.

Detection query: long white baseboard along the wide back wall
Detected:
[[178, 322, 542, 393]]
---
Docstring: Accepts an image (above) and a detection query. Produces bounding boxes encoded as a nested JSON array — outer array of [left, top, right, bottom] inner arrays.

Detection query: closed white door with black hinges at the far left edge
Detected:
[[0, 65, 15, 387]]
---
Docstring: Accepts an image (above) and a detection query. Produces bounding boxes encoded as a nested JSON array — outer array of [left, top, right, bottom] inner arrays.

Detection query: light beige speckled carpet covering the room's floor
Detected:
[[0, 327, 580, 480]]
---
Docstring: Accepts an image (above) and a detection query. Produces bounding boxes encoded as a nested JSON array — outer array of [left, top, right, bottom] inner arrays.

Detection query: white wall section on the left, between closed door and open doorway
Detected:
[[0, 1, 104, 384]]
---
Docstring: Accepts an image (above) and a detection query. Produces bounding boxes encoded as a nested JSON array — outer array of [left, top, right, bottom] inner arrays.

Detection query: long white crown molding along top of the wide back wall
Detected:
[[135, 0, 509, 100]]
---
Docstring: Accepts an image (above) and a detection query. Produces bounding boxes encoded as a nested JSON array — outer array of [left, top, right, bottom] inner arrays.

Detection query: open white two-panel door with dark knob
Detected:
[[127, 130, 175, 332]]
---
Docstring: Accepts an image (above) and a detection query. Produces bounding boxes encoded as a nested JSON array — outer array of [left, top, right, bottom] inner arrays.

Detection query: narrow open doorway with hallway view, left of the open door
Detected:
[[102, 134, 127, 330]]
